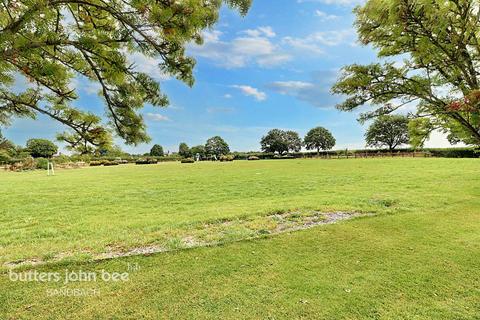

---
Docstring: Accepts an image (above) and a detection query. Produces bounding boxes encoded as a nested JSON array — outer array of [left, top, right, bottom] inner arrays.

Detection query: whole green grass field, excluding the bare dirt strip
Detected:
[[0, 159, 480, 319]]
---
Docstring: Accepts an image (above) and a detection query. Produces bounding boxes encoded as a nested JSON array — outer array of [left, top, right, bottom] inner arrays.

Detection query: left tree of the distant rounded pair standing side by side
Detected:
[[260, 129, 302, 154]]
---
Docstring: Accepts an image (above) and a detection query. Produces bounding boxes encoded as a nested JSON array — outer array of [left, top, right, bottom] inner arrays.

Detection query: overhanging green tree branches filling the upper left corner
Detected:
[[0, 0, 251, 148]]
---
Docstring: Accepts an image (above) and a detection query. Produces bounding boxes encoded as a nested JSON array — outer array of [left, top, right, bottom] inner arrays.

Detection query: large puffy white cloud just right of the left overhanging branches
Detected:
[[189, 27, 292, 69]]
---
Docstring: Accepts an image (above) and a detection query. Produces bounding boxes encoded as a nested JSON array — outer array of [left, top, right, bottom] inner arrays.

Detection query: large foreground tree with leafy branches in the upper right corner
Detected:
[[332, 0, 480, 145]]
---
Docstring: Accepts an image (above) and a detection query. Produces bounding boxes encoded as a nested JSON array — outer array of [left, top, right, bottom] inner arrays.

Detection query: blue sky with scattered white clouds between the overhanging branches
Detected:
[[4, 0, 454, 153]]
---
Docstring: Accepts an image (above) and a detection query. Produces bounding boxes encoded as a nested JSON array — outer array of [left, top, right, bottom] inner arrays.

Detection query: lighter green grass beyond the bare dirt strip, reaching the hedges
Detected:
[[0, 159, 480, 264]]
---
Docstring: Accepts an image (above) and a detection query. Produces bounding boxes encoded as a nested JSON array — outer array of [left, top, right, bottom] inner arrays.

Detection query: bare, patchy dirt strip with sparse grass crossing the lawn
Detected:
[[4, 211, 371, 268]]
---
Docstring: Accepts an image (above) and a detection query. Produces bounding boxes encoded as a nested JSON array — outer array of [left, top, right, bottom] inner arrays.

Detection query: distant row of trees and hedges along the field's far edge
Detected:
[[0, 115, 475, 169]]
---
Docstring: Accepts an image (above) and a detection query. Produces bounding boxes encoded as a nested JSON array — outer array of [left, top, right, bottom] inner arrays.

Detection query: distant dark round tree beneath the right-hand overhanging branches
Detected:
[[365, 115, 409, 151]]
